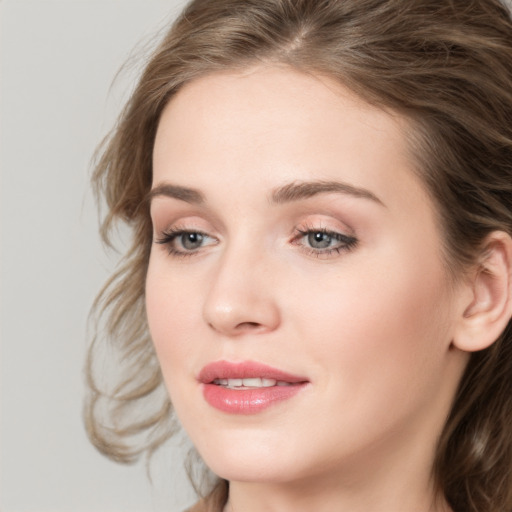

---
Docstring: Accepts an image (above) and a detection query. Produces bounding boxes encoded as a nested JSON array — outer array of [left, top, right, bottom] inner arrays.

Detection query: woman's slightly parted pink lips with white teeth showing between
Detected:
[[198, 361, 308, 414]]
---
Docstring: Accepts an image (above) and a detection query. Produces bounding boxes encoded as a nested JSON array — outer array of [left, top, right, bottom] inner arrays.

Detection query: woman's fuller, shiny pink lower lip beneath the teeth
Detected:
[[203, 382, 306, 414]]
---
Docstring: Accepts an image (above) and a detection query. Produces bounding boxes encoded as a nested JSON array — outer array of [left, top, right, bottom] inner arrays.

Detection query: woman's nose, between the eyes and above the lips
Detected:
[[203, 243, 281, 337]]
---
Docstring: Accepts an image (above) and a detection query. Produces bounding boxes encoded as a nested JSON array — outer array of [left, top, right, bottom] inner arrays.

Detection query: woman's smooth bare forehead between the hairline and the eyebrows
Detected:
[[153, 67, 428, 215]]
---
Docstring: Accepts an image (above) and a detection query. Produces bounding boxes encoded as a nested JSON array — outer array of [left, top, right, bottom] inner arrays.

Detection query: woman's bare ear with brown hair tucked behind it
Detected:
[[453, 231, 512, 352]]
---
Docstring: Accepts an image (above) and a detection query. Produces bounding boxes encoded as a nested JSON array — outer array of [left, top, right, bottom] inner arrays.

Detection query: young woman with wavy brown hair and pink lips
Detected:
[[86, 0, 512, 512]]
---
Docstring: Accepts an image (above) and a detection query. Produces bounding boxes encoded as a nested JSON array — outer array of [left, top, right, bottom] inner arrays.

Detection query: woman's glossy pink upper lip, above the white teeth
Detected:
[[198, 361, 308, 384]]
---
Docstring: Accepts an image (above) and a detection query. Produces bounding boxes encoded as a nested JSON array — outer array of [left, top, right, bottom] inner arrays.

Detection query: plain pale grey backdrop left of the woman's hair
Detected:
[[0, 0, 194, 512]]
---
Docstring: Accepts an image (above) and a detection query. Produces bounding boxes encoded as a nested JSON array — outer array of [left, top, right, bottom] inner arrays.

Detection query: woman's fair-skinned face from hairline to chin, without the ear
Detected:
[[146, 68, 465, 482]]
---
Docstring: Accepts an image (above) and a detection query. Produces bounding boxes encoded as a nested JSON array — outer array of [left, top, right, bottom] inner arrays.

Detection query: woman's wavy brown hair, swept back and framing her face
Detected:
[[85, 0, 512, 512]]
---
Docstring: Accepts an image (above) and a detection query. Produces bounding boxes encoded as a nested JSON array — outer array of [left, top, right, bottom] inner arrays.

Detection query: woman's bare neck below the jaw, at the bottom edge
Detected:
[[224, 422, 450, 512]]
